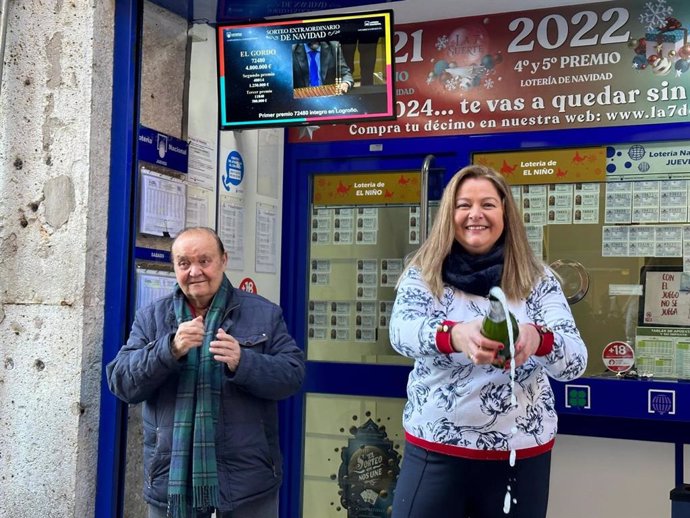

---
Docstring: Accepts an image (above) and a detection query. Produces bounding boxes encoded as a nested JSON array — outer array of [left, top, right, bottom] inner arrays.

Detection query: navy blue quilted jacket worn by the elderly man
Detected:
[[106, 288, 304, 511]]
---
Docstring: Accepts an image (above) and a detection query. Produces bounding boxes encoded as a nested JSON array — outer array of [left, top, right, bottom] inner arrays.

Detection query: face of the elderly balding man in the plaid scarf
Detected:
[[172, 230, 228, 309]]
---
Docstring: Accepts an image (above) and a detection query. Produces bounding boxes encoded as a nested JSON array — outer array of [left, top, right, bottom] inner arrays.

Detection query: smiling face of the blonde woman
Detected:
[[453, 178, 505, 254]]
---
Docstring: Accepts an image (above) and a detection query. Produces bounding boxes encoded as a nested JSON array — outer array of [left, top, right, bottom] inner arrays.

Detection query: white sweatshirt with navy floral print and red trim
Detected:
[[389, 268, 587, 459]]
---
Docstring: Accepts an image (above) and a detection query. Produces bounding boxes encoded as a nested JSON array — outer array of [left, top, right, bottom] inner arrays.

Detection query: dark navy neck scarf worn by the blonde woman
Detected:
[[441, 238, 504, 297]]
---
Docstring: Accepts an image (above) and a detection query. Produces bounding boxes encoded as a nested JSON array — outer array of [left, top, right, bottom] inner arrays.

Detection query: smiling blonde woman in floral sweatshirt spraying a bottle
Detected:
[[389, 165, 587, 518]]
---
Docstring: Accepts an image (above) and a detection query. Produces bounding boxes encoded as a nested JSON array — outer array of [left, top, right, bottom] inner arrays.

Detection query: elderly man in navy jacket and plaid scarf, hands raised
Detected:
[[107, 228, 304, 518]]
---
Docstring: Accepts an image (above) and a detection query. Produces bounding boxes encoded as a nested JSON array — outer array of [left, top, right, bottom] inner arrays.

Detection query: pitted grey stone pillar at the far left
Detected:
[[0, 0, 114, 518]]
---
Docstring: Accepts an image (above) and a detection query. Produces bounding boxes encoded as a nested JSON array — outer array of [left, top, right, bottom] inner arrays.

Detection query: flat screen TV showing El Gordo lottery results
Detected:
[[217, 10, 395, 130]]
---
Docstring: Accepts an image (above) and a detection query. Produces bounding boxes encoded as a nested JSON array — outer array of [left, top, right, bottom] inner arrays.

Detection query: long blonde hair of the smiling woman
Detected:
[[406, 165, 544, 300]]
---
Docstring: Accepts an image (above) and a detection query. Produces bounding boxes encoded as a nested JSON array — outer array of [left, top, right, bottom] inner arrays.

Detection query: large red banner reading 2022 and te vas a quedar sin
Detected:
[[289, 0, 690, 142]]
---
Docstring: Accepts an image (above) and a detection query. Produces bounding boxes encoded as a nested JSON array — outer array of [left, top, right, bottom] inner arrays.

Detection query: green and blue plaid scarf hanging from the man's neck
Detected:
[[168, 277, 231, 518]]
